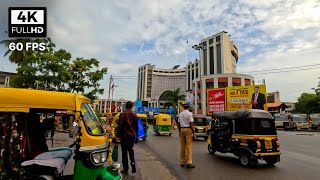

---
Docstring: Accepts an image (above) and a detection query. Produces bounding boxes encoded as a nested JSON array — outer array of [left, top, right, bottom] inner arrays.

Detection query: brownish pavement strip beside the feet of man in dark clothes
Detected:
[[119, 142, 177, 180]]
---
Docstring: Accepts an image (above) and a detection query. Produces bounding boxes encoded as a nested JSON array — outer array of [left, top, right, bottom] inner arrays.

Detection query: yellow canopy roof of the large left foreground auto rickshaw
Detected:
[[0, 88, 91, 113]]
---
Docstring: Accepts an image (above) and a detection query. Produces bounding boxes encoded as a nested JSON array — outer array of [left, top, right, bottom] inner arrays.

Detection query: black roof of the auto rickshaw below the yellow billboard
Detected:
[[212, 109, 274, 119]]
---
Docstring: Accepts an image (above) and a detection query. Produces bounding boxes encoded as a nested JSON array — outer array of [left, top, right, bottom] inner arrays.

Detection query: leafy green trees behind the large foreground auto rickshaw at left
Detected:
[[0, 38, 107, 100]]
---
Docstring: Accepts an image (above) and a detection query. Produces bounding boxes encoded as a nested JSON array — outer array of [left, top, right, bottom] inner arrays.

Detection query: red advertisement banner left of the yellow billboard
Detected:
[[207, 89, 226, 115]]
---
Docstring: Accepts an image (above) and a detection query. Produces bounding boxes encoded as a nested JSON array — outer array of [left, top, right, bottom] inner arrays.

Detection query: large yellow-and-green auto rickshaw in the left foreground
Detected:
[[0, 88, 122, 180]]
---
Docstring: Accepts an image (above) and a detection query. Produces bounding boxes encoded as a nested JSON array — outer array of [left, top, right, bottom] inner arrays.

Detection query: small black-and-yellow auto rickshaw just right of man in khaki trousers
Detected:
[[193, 114, 209, 140]]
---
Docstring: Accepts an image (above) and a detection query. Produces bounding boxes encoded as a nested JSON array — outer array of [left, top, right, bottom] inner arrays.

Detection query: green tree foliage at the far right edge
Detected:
[[294, 82, 320, 114]]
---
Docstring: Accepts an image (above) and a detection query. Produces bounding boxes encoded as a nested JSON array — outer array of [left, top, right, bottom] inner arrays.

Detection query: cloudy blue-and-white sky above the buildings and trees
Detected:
[[0, 0, 320, 101]]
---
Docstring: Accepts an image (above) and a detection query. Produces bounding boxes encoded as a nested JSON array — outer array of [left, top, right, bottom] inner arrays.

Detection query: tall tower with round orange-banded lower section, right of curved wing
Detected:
[[190, 31, 254, 114]]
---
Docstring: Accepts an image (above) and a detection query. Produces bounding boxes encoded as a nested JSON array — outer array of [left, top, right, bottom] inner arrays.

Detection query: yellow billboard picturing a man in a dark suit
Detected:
[[226, 85, 268, 111]]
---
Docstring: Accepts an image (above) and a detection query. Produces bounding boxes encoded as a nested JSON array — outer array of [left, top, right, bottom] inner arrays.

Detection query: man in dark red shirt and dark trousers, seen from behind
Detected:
[[117, 101, 138, 174]]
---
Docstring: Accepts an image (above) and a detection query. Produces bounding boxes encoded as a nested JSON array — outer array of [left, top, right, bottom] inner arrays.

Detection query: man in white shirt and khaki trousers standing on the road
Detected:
[[178, 104, 196, 168]]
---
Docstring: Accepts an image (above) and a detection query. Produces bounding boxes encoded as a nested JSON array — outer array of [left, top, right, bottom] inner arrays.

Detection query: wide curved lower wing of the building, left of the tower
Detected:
[[137, 64, 186, 101]]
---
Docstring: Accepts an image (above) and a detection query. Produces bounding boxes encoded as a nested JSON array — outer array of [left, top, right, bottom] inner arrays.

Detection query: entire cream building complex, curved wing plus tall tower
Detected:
[[137, 31, 254, 114]]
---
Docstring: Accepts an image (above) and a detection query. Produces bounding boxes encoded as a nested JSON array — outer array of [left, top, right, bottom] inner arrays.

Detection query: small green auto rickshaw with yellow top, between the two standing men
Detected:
[[153, 114, 172, 136]]
